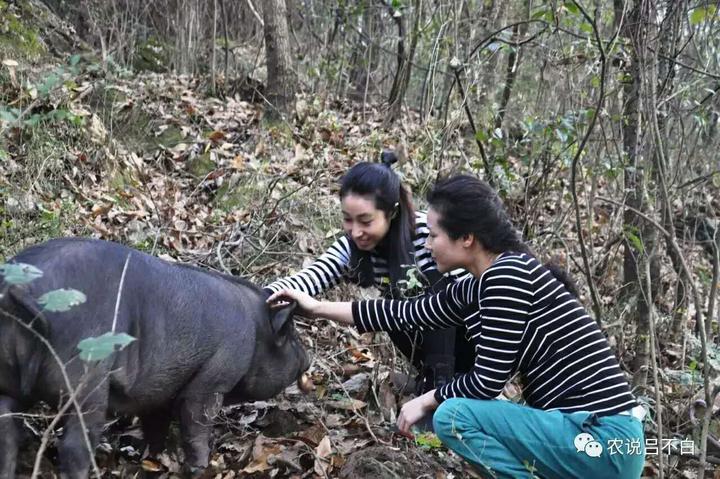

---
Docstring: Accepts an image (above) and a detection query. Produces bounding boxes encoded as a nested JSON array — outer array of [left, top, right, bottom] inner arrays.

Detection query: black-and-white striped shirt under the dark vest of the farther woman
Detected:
[[265, 211, 467, 296]]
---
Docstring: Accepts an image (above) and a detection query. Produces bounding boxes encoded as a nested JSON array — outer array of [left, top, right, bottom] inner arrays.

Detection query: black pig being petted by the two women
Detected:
[[0, 238, 309, 478]]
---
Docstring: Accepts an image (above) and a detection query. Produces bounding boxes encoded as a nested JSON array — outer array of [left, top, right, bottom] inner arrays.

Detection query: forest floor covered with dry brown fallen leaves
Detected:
[[0, 1, 716, 478]]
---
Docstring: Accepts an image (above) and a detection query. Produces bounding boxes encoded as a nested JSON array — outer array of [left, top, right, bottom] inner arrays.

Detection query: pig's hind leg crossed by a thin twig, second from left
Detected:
[[58, 381, 108, 479]]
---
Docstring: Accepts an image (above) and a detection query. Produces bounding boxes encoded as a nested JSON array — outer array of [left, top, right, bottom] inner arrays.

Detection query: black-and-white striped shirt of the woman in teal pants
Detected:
[[352, 252, 637, 415]]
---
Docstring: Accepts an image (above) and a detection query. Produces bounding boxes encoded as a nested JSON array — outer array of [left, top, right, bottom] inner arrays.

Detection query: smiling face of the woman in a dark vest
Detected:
[[340, 193, 390, 251]]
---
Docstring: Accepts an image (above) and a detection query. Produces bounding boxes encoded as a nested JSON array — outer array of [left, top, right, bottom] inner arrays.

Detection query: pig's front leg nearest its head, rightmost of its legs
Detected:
[[180, 394, 222, 473]]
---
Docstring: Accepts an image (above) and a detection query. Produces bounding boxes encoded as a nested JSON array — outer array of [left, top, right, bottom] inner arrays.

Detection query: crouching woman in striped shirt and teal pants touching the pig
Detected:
[[268, 176, 645, 479]]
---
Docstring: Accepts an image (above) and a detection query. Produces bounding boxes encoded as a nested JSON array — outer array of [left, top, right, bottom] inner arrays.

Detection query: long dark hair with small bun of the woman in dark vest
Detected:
[[340, 151, 415, 296]]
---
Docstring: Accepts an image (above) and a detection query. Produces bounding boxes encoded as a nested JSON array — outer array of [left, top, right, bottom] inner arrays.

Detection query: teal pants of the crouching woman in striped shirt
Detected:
[[433, 398, 645, 479]]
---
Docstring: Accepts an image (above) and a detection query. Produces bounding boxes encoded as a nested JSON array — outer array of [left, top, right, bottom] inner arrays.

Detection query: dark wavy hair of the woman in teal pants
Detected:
[[427, 175, 579, 297]]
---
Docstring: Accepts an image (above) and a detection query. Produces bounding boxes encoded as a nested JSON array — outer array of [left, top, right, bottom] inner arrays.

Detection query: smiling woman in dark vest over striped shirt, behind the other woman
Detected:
[[265, 151, 474, 393]]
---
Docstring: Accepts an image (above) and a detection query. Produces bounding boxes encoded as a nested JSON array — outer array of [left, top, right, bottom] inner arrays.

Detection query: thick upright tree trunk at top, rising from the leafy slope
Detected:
[[263, 0, 295, 119]]
